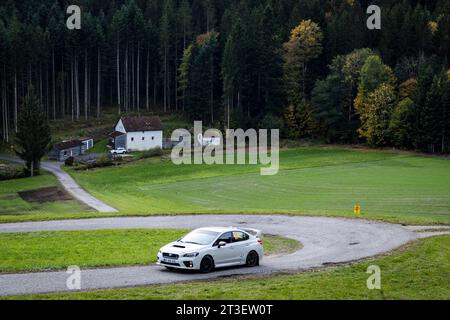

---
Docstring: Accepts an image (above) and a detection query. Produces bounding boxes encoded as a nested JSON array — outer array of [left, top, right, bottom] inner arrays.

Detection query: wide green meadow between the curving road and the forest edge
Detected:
[[0, 147, 450, 224]]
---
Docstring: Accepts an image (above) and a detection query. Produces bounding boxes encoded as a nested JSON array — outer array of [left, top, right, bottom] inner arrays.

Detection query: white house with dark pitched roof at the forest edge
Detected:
[[109, 117, 163, 151]]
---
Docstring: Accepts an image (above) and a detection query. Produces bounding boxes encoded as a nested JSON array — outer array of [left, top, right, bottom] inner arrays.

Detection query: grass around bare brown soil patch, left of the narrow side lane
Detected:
[[0, 172, 87, 219]]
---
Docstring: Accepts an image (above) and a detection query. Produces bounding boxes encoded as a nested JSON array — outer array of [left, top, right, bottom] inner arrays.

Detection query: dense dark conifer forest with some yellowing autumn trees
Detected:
[[0, 0, 450, 152]]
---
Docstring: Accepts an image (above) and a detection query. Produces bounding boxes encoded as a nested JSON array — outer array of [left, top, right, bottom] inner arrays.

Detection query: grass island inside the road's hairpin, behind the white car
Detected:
[[0, 229, 299, 272]]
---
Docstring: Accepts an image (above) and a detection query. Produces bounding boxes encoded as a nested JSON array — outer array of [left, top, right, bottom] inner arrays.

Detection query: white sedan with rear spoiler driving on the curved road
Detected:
[[157, 227, 263, 273]]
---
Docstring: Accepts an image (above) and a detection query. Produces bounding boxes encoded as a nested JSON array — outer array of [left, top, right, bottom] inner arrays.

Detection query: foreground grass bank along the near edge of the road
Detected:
[[9, 236, 450, 300]]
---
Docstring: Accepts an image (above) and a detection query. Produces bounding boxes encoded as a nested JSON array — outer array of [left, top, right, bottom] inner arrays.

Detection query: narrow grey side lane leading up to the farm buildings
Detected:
[[0, 156, 117, 213]]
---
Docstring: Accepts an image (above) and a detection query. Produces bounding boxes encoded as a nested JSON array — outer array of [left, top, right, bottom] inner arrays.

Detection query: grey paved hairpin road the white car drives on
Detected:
[[0, 215, 428, 295]]
